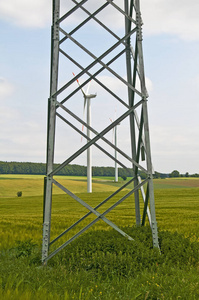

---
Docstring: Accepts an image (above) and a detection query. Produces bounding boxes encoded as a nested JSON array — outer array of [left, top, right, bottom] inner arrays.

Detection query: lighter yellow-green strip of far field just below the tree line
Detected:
[[0, 175, 199, 197]]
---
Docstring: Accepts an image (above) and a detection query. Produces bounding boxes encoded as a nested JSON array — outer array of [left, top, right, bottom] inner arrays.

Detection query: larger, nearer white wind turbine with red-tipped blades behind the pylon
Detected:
[[73, 73, 97, 193]]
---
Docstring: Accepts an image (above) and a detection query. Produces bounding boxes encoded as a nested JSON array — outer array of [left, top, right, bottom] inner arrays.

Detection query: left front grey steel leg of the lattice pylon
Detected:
[[42, 0, 60, 262]]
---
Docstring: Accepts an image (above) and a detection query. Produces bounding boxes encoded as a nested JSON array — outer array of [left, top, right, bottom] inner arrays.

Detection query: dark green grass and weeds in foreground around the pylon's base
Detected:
[[0, 227, 199, 300]]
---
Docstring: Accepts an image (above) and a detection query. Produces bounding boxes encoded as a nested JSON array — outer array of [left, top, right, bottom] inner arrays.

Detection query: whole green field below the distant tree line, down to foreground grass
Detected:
[[0, 175, 199, 300]]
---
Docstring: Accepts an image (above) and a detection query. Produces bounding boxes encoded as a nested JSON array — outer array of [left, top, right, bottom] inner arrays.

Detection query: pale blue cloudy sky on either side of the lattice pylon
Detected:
[[0, 0, 199, 174]]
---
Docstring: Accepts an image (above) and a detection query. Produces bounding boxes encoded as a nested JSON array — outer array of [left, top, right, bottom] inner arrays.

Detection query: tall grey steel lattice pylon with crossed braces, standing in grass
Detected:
[[42, 0, 158, 264]]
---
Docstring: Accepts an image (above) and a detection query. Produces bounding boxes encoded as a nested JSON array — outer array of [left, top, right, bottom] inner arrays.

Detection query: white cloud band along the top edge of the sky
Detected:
[[0, 0, 199, 40]]
